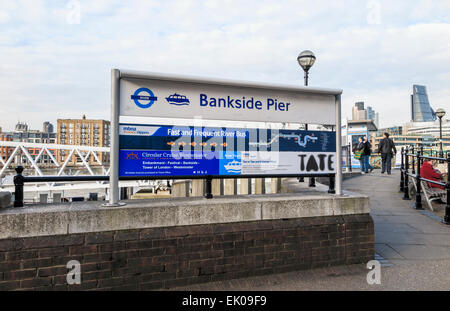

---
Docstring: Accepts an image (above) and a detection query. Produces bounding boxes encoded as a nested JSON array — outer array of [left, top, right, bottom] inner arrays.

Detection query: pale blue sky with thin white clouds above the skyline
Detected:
[[0, 0, 450, 130]]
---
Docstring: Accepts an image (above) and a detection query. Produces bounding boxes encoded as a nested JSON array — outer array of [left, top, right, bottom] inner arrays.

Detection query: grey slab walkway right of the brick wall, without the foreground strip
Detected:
[[344, 170, 450, 264]]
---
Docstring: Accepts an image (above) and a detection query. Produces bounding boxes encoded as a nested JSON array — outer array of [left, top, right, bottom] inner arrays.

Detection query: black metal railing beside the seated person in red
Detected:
[[400, 147, 450, 225]]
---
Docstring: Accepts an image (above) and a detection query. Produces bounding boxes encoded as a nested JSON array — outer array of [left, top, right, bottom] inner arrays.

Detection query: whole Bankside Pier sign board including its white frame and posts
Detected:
[[110, 69, 342, 206]]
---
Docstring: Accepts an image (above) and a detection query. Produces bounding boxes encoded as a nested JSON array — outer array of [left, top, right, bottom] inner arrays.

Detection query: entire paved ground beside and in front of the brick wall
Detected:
[[173, 170, 450, 290]]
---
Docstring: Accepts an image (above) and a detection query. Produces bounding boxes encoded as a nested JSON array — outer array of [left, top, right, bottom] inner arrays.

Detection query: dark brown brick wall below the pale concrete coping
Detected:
[[0, 214, 374, 290]]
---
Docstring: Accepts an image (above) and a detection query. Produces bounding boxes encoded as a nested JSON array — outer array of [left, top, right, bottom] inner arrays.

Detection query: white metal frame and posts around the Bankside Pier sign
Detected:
[[106, 69, 342, 206]]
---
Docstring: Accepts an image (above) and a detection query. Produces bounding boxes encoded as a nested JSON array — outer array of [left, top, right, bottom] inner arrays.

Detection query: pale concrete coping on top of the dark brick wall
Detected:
[[0, 192, 369, 239]]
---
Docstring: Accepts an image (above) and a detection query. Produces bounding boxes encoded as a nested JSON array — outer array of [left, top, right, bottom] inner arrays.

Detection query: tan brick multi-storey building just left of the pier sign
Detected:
[[56, 115, 110, 165]]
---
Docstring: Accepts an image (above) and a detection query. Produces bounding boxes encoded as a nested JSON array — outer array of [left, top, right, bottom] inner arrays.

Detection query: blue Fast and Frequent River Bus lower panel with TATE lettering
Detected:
[[119, 124, 336, 177]]
